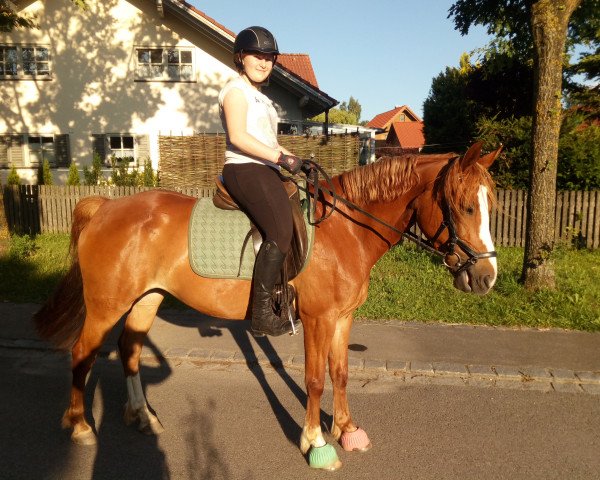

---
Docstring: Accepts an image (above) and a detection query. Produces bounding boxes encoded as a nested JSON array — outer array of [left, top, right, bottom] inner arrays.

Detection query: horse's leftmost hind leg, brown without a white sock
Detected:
[[62, 308, 119, 445]]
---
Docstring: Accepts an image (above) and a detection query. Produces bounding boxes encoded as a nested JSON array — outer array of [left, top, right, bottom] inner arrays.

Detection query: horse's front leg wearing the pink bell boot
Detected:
[[329, 315, 371, 452]]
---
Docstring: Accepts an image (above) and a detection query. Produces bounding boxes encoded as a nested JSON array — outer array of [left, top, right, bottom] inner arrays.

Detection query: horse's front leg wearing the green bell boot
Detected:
[[300, 316, 342, 470]]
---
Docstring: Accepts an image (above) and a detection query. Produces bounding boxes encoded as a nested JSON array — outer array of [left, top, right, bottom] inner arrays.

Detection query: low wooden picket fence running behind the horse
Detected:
[[0, 185, 600, 249]]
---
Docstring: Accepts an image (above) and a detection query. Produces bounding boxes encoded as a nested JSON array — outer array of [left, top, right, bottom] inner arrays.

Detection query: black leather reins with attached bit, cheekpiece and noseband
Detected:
[[296, 160, 497, 276]]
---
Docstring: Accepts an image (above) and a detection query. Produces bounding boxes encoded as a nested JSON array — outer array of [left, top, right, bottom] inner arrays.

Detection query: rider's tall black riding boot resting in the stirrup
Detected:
[[252, 240, 296, 337]]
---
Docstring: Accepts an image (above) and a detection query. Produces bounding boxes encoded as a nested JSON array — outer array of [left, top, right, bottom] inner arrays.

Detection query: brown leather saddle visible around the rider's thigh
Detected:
[[213, 175, 309, 280]]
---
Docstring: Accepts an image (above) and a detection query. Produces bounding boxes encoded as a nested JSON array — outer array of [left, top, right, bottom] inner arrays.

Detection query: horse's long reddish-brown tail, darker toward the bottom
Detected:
[[33, 197, 108, 350]]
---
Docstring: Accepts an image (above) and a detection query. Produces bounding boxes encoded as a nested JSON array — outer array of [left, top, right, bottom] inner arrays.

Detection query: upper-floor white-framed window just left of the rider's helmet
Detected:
[[135, 47, 194, 82]]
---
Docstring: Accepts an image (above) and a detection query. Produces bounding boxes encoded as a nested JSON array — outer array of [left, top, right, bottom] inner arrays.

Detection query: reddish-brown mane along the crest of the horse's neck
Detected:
[[340, 155, 419, 203]]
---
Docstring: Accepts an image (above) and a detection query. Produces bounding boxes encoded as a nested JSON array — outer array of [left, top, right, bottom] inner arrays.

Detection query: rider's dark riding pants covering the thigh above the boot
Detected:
[[223, 163, 293, 253]]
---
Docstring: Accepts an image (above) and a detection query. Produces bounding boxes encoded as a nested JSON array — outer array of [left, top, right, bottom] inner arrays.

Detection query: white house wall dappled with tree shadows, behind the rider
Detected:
[[0, 0, 235, 183]]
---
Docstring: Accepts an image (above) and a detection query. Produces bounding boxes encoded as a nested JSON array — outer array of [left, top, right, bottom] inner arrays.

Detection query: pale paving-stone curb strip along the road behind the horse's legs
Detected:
[[0, 339, 600, 395]]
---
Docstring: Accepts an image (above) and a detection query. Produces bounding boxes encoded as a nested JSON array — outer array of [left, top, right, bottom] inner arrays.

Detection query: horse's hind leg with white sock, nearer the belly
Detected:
[[119, 292, 164, 435]]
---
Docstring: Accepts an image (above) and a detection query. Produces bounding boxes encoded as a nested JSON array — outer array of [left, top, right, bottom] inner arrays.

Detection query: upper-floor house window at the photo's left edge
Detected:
[[0, 45, 50, 79]]
